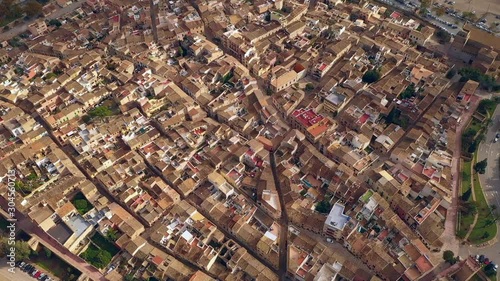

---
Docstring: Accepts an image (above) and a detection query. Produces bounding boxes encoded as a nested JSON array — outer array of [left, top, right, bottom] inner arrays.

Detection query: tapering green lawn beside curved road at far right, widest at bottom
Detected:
[[469, 153, 498, 244]]
